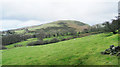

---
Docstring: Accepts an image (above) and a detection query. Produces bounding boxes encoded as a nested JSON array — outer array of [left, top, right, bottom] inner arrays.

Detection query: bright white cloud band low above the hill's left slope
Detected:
[[0, 20, 47, 31]]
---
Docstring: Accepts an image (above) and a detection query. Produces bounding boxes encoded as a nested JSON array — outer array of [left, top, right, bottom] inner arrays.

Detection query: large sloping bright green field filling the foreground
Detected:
[[2, 33, 118, 65]]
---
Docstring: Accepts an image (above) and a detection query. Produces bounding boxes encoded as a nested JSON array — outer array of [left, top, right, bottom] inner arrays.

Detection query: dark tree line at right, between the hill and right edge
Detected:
[[84, 18, 120, 34]]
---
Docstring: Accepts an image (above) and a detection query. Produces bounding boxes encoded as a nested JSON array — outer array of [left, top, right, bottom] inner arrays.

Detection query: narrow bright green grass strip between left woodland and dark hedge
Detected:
[[5, 38, 38, 48]]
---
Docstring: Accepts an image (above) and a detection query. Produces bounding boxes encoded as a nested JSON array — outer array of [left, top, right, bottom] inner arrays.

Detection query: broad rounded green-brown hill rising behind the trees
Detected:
[[15, 20, 89, 33]]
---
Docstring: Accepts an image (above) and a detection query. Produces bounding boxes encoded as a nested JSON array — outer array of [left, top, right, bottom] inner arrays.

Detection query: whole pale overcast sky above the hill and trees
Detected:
[[0, 0, 119, 30]]
